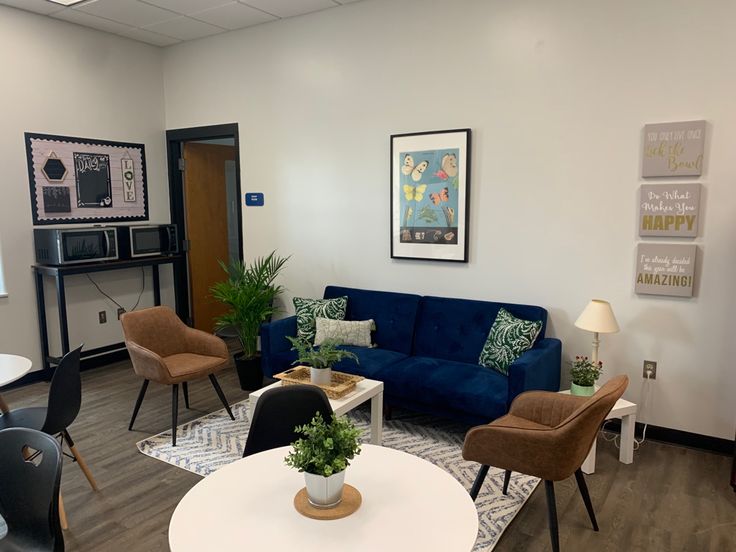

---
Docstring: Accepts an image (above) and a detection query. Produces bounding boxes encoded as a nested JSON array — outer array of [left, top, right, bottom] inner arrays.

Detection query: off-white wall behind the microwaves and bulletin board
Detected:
[[0, 6, 171, 369]]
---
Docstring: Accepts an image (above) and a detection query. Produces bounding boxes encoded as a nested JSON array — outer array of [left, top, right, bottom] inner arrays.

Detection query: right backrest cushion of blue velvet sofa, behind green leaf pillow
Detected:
[[412, 297, 547, 365]]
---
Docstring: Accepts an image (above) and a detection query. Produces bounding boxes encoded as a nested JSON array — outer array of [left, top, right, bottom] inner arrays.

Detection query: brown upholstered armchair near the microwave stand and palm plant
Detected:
[[120, 307, 235, 446]]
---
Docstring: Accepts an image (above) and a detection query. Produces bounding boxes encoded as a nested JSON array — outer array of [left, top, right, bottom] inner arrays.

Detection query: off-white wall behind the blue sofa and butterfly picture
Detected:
[[164, 0, 736, 439]]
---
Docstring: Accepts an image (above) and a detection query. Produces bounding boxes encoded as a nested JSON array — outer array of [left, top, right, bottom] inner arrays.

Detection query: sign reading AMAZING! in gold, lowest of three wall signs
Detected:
[[634, 243, 697, 297]]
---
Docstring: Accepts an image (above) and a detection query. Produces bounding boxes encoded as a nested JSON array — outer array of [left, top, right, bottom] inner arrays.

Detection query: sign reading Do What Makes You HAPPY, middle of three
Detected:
[[639, 184, 701, 238]]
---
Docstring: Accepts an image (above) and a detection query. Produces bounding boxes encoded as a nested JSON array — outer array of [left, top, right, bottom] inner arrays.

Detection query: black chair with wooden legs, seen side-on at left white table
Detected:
[[0, 345, 97, 496]]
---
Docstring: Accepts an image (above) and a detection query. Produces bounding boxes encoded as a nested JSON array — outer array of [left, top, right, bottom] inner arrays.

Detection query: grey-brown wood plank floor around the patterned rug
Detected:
[[3, 362, 736, 552]]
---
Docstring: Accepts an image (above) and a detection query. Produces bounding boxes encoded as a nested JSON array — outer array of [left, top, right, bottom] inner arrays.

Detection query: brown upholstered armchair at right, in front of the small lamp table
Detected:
[[463, 376, 629, 552]]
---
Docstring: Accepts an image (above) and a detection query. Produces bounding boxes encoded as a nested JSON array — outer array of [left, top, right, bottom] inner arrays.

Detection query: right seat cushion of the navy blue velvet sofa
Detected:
[[375, 356, 508, 421]]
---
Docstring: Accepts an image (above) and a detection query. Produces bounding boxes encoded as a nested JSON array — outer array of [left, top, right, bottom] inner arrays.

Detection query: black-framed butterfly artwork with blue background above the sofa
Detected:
[[391, 128, 470, 263]]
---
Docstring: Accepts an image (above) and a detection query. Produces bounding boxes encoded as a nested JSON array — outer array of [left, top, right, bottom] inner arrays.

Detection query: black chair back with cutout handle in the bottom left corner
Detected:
[[0, 428, 64, 552]]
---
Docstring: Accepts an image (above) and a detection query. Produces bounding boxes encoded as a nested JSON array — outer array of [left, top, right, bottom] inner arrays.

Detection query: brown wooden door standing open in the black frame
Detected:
[[184, 142, 235, 332]]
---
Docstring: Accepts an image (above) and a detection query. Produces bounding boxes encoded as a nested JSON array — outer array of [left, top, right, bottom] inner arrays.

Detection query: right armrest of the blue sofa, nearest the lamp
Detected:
[[506, 337, 562, 407]]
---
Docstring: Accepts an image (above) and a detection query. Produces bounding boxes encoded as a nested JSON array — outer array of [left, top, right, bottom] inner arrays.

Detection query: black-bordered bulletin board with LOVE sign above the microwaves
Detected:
[[25, 133, 148, 225]]
